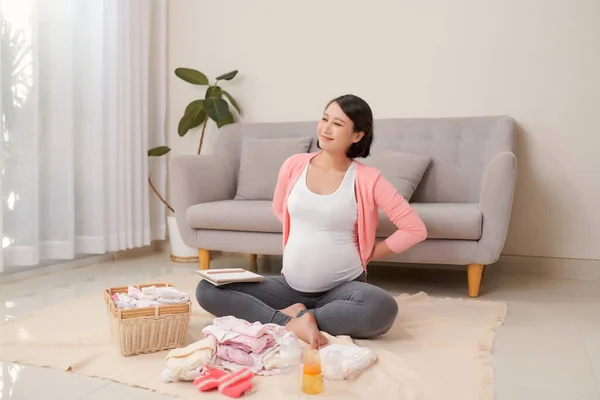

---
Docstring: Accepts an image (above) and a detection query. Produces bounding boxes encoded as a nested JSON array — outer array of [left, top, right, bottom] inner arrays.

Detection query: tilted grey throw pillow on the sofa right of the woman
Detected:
[[359, 149, 431, 201]]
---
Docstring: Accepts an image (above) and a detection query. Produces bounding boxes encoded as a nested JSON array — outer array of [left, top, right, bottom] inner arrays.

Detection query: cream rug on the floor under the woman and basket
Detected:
[[0, 274, 506, 400]]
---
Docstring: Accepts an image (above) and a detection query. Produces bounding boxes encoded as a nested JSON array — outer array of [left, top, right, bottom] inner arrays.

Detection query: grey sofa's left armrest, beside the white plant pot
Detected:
[[169, 154, 236, 247]]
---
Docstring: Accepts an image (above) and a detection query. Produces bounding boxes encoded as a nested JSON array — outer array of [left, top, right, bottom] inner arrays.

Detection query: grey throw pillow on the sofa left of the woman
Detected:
[[235, 137, 312, 200]]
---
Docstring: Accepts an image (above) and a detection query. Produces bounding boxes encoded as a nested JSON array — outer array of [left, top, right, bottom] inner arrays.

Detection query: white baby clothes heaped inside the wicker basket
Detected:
[[112, 286, 190, 309]]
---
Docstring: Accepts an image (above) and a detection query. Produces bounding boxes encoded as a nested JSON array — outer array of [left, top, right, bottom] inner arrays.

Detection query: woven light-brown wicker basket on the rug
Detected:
[[104, 283, 192, 356]]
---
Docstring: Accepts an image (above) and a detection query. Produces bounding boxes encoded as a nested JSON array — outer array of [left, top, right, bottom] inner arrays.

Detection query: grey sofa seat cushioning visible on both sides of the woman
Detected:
[[186, 200, 482, 240]]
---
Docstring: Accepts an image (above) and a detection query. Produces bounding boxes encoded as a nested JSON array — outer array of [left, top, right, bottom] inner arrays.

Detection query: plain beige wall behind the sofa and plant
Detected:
[[169, 0, 600, 259]]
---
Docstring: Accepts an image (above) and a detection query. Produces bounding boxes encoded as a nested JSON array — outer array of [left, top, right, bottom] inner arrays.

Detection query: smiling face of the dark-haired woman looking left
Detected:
[[317, 102, 364, 154]]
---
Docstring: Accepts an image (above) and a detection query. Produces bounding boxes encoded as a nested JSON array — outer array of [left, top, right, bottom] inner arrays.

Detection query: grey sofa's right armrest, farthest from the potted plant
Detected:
[[473, 151, 517, 265]]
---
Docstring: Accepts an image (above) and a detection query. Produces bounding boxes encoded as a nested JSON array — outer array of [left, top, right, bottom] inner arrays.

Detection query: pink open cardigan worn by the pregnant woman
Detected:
[[273, 153, 427, 270]]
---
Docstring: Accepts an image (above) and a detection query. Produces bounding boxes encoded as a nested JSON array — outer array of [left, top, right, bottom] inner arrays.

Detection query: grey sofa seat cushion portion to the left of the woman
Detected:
[[186, 200, 283, 233]]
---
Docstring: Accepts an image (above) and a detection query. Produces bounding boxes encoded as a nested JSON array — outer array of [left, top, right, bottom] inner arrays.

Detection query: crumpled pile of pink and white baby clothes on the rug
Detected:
[[202, 316, 287, 375]]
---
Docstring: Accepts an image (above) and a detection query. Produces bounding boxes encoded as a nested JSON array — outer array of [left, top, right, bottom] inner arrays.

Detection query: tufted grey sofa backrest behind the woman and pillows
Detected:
[[214, 116, 517, 203]]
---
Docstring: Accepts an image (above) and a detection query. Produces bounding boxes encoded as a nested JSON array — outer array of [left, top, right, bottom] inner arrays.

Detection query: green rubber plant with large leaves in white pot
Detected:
[[148, 68, 242, 262]]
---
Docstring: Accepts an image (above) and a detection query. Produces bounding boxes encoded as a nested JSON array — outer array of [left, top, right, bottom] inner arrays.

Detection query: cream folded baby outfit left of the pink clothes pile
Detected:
[[161, 337, 217, 382]]
